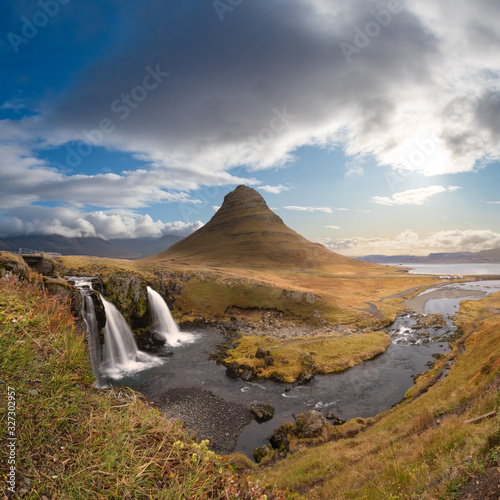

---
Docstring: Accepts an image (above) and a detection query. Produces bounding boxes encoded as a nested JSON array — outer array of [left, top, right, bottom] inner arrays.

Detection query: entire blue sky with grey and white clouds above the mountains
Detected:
[[0, 0, 500, 256]]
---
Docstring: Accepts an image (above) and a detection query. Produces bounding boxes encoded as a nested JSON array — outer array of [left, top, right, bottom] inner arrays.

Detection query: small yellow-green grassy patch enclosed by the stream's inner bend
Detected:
[[224, 332, 390, 383]]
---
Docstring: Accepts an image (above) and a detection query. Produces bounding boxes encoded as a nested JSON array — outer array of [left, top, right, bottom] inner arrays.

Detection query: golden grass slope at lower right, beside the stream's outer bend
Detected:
[[256, 293, 500, 500]]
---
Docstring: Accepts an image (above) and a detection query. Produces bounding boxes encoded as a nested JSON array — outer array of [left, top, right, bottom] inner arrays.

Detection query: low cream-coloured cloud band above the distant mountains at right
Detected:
[[317, 229, 500, 256]]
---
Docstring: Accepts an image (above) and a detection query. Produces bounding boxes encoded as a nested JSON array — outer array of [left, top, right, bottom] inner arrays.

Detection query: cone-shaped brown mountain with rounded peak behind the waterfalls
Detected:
[[143, 186, 373, 272]]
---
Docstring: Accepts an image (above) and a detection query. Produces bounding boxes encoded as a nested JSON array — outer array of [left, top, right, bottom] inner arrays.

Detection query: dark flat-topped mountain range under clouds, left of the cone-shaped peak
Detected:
[[0, 234, 181, 259]]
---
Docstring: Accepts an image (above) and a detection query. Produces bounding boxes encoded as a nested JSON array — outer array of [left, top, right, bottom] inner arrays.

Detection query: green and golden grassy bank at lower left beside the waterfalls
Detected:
[[0, 280, 288, 500]]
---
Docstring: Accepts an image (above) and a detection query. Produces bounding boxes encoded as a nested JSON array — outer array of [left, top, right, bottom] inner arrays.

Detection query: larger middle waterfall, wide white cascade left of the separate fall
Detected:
[[101, 295, 161, 377]]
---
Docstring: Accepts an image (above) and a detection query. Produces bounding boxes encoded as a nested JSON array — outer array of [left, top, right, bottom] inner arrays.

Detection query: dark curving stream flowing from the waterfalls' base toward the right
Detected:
[[92, 280, 500, 457]]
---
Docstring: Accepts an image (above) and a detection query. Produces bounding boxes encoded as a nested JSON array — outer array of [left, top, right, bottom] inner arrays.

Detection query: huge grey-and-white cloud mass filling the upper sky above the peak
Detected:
[[31, 0, 500, 175]]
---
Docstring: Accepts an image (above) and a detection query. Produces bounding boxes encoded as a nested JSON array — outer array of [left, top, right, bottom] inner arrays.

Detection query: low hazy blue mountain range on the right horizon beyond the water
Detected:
[[358, 248, 500, 264]]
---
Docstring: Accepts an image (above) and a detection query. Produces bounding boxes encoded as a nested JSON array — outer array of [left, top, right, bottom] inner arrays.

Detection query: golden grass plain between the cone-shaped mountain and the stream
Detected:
[[60, 257, 439, 329]]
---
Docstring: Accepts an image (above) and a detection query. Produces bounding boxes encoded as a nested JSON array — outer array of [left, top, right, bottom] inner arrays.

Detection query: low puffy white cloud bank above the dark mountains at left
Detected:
[[0, 207, 203, 239]]
